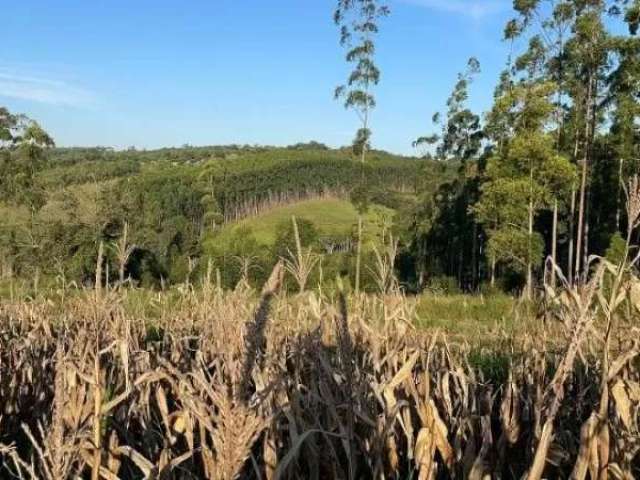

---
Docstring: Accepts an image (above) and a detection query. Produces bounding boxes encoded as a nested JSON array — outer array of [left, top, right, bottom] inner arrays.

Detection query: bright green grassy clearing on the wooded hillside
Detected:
[[207, 199, 393, 245]]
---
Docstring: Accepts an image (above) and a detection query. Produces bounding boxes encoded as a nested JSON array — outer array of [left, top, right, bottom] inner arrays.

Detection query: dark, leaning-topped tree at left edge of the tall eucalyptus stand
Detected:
[[405, 58, 485, 290]]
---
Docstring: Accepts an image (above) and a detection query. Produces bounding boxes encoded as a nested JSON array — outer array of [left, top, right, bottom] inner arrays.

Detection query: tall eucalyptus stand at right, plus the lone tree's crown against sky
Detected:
[[336, 0, 640, 296]]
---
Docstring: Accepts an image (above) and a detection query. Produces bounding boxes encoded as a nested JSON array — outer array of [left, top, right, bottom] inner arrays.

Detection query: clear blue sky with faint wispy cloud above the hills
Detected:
[[0, 0, 511, 153]]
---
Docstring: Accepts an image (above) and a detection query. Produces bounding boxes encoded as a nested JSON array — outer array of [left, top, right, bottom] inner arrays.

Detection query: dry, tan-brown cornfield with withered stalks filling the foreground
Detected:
[[0, 196, 640, 480]]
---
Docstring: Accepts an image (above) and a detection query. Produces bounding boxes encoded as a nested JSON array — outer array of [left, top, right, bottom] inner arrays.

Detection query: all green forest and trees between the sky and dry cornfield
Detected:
[[0, 0, 640, 294]]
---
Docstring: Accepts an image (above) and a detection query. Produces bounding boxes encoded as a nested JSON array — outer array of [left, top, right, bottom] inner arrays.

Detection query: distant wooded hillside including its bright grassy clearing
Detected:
[[0, 143, 440, 286]]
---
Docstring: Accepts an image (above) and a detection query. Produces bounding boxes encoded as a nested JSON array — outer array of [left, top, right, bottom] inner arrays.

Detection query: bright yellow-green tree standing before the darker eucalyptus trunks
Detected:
[[474, 82, 575, 282]]
